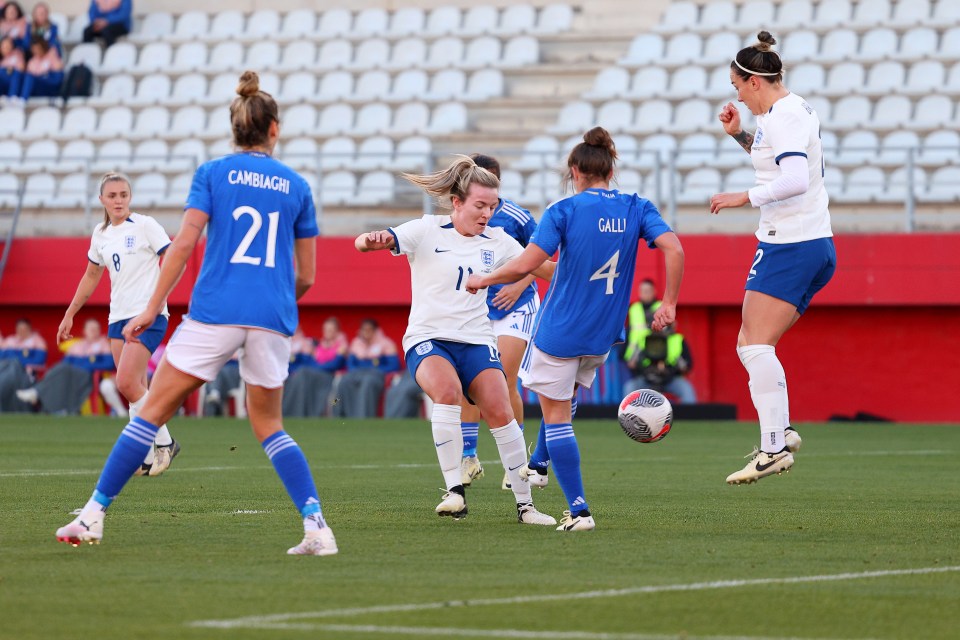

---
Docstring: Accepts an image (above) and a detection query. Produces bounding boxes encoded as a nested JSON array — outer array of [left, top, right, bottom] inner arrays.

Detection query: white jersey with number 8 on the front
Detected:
[[87, 213, 170, 324]]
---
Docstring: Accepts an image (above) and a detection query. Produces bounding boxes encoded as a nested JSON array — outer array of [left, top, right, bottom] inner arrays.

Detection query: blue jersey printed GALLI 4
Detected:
[[530, 189, 670, 358]]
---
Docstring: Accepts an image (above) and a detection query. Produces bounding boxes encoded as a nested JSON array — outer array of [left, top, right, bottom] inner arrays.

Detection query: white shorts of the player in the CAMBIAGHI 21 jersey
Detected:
[[164, 318, 291, 389]]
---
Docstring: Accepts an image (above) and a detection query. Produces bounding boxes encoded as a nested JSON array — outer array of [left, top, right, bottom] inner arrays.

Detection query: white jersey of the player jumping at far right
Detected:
[[750, 93, 833, 244]]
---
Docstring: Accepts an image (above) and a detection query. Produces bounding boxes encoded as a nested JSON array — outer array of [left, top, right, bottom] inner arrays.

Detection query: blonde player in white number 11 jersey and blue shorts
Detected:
[[355, 156, 556, 525]]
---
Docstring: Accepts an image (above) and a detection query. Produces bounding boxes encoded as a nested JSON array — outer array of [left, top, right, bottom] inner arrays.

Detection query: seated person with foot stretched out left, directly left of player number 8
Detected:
[[17, 318, 114, 415]]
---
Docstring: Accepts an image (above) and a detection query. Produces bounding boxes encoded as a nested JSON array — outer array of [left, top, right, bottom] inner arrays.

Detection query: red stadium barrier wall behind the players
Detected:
[[0, 234, 960, 421]]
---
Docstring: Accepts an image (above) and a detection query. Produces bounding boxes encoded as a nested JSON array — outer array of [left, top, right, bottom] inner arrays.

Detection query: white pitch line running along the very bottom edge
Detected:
[[214, 622, 866, 640]]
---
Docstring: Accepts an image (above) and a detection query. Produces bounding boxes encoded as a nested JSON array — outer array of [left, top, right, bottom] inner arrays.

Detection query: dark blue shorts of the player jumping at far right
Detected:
[[744, 238, 837, 315]]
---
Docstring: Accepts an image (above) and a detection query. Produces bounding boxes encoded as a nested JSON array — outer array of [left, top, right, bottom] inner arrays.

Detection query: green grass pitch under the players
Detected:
[[0, 415, 960, 640]]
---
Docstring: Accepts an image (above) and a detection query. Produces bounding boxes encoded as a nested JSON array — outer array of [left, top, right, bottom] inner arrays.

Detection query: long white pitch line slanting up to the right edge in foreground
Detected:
[[189, 566, 960, 629]]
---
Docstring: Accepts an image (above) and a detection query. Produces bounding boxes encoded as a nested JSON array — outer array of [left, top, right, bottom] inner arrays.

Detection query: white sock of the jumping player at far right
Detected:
[[737, 344, 789, 453]]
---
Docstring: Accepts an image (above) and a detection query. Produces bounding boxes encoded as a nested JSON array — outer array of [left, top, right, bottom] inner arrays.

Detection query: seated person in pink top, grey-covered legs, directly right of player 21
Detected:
[[283, 318, 347, 418]]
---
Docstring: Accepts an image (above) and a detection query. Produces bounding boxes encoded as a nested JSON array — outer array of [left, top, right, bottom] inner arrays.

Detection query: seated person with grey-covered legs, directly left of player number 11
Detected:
[[335, 318, 400, 418]]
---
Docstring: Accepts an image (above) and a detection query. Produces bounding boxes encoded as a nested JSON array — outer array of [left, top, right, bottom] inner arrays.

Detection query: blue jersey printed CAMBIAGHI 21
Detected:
[[185, 152, 319, 336]]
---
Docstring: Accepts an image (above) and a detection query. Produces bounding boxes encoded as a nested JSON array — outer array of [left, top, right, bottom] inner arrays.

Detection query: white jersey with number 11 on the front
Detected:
[[389, 216, 523, 352]]
